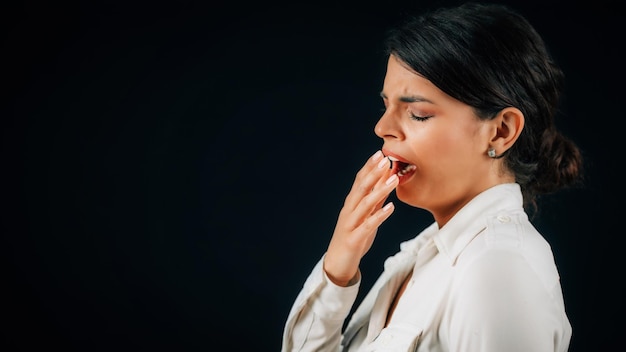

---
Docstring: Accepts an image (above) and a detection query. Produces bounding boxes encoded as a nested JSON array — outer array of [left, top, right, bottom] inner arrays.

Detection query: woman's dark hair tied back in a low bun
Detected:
[[385, 2, 582, 214]]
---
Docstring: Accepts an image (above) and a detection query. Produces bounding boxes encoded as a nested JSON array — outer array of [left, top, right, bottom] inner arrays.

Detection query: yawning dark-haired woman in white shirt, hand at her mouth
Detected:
[[282, 3, 582, 352]]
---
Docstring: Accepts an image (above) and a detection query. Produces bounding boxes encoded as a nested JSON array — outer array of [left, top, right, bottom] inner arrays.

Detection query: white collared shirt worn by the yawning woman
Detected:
[[281, 183, 572, 352]]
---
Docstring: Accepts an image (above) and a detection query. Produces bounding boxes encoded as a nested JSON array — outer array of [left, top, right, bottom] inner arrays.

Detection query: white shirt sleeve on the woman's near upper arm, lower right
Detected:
[[448, 250, 570, 352]]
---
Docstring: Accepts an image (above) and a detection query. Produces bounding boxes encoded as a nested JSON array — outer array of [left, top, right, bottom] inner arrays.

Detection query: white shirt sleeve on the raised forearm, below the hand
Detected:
[[281, 257, 361, 352]]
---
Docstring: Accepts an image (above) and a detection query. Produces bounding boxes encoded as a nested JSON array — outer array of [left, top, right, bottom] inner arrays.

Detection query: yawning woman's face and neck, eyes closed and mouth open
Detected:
[[375, 56, 494, 224]]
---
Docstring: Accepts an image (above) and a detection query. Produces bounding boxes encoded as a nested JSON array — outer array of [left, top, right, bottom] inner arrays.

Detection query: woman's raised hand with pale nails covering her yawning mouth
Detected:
[[324, 151, 398, 286]]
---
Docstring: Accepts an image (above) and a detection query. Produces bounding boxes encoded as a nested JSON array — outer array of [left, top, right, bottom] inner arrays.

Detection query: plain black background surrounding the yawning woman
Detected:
[[0, 1, 625, 351]]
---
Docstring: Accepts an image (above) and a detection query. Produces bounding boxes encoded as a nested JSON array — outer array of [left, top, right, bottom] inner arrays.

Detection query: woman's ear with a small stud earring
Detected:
[[489, 107, 524, 155]]
